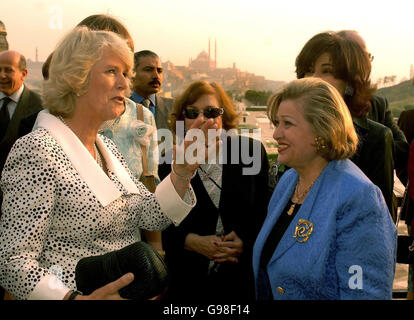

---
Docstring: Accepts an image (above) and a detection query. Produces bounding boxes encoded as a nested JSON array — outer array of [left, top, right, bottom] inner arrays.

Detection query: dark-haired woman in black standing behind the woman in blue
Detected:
[[296, 31, 396, 221]]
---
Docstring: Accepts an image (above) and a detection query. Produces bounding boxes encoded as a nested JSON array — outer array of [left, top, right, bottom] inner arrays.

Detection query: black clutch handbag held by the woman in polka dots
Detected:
[[75, 241, 168, 300]]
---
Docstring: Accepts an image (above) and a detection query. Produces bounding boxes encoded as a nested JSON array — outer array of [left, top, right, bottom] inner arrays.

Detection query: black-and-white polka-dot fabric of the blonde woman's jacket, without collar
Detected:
[[0, 128, 171, 299]]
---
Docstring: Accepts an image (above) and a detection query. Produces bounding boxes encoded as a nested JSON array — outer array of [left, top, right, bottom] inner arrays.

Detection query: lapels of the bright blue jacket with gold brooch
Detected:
[[259, 161, 335, 268]]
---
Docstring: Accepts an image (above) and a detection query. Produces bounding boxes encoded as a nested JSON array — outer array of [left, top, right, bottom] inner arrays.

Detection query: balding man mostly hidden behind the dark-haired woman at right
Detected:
[[337, 30, 409, 184]]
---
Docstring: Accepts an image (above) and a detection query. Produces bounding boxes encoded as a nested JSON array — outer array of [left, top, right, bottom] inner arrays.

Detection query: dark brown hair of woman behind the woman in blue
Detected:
[[295, 31, 376, 117]]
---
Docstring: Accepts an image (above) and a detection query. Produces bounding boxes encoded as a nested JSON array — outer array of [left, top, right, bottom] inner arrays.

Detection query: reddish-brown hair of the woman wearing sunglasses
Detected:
[[170, 81, 239, 134]]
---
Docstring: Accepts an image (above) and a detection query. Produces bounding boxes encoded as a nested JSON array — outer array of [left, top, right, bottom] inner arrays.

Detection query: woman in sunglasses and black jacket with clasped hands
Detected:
[[159, 81, 268, 302]]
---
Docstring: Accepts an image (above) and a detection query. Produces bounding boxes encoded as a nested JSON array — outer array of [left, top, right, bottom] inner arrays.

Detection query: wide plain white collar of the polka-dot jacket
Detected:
[[38, 113, 139, 207]]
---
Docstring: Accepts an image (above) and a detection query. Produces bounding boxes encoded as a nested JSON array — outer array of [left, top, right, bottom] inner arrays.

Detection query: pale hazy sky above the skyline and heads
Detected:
[[0, 0, 414, 81]]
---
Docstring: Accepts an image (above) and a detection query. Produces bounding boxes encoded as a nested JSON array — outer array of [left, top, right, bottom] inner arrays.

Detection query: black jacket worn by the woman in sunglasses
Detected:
[[159, 137, 269, 302]]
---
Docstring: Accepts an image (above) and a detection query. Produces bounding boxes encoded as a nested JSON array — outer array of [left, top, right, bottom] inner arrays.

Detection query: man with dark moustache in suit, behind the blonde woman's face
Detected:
[[131, 50, 173, 133]]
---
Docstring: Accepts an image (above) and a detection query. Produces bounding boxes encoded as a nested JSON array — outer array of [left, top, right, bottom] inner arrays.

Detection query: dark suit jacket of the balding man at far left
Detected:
[[0, 86, 43, 171]]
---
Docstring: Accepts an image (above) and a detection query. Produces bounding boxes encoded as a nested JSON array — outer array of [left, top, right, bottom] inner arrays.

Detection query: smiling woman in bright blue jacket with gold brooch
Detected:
[[253, 77, 397, 300]]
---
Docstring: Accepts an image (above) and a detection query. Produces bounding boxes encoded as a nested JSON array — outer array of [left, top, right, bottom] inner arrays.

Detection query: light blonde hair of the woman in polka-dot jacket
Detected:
[[42, 27, 134, 117]]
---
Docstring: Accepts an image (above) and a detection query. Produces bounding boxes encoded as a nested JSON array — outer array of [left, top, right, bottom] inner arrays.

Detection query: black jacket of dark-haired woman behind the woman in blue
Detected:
[[351, 118, 396, 221]]
